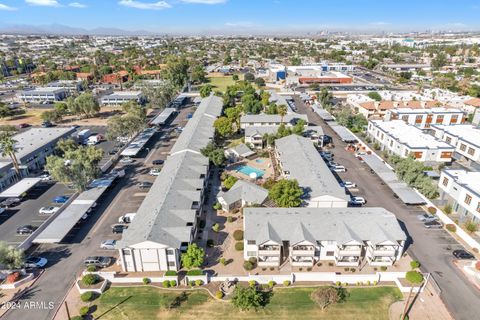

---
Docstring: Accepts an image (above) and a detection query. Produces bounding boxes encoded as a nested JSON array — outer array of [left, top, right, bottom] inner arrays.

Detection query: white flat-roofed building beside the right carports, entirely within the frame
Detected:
[[367, 120, 455, 164]]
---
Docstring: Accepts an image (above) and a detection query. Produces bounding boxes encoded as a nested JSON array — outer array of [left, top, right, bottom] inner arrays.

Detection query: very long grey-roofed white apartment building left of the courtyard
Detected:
[[117, 96, 223, 272]]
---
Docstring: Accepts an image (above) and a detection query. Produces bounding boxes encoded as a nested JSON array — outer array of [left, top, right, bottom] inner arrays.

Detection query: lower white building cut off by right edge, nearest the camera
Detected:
[[438, 170, 480, 222]]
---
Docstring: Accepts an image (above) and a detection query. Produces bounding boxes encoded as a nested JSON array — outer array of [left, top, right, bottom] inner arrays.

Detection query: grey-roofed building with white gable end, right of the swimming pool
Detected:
[[275, 134, 349, 208]]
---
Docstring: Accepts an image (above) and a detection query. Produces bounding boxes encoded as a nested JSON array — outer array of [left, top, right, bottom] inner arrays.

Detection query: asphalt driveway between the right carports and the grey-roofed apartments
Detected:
[[295, 99, 480, 320]]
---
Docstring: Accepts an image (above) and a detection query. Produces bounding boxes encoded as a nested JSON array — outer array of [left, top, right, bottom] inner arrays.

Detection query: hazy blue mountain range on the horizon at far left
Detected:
[[0, 24, 156, 36]]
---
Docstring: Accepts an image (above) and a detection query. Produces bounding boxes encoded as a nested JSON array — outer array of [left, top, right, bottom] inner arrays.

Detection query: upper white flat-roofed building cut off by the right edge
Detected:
[[430, 124, 480, 163]]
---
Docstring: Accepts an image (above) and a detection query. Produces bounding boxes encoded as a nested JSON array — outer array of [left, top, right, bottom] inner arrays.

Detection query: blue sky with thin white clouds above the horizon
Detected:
[[0, 0, 480, 33]]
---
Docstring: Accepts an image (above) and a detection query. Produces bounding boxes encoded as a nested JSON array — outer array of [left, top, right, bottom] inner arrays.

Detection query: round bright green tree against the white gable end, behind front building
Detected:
[[268, 179, 303, 208]]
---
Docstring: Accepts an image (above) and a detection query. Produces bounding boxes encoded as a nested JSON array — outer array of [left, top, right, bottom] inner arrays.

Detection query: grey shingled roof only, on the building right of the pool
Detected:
[[275, 134, 349, 200]]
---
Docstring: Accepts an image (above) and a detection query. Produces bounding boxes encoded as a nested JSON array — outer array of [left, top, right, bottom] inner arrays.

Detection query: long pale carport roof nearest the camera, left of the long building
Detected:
[[33, 173, 118, 243]]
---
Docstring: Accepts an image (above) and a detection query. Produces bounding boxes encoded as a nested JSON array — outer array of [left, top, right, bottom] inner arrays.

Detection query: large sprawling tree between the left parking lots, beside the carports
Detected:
[[45, 146, 103, 192]]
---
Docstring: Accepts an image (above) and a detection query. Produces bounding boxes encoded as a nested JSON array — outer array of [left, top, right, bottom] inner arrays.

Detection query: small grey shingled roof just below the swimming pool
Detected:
[[217, 180, 268, 205]]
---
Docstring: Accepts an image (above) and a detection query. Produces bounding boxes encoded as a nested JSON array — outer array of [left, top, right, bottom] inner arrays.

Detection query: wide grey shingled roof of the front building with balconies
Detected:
[[243, 207, 407, 245]]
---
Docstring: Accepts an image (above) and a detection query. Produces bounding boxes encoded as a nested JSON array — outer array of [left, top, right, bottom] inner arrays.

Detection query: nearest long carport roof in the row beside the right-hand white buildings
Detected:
[[362, 154, 425, 205]]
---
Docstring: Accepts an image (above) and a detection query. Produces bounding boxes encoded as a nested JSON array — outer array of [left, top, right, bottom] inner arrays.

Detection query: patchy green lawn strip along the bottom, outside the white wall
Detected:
[[92, 287, 401, 320]]
